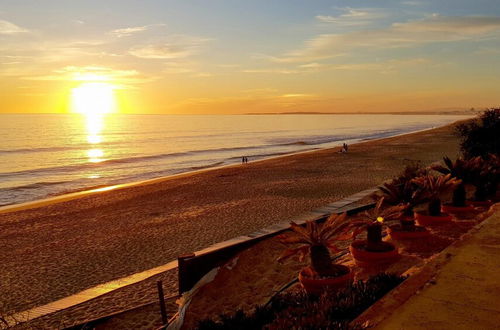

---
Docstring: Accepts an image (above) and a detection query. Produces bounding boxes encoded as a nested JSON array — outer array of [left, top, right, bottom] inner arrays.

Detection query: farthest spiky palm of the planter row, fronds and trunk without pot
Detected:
[[431, 157, 477, 207]]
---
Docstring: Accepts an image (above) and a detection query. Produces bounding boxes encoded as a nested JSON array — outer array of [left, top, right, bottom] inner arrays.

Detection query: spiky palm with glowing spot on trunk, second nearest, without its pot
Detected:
[[351, 197, 407, 251]]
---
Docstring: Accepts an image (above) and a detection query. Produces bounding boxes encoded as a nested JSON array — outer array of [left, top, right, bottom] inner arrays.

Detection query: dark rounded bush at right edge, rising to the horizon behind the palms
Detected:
[[456, 108, 500, 159]]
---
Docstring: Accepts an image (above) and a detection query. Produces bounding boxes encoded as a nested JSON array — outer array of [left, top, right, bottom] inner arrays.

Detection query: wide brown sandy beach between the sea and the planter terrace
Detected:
[[0, 125, 458, 312]]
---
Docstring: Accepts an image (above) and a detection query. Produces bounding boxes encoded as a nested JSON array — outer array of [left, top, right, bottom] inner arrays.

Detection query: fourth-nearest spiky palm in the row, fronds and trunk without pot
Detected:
[[413, 174, 461, 216]]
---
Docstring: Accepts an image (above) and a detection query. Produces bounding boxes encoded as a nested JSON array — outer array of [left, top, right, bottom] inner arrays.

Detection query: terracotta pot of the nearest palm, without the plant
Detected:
[[299, 265, 354, 295]]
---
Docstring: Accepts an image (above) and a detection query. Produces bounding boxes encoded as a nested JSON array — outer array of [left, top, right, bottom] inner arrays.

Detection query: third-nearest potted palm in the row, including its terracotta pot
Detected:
[[379, 165, 429, 239]]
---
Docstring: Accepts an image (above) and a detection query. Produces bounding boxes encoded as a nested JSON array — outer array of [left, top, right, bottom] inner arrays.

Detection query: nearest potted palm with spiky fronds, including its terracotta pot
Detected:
[[278, 213, 353, 294]]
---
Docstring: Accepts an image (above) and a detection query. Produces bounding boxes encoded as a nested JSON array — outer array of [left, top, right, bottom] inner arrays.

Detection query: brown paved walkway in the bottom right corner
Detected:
[[372, 208, 500, 330]]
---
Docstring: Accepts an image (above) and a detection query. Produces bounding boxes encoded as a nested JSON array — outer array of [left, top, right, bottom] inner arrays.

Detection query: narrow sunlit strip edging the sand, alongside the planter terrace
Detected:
[[6, 188, 378, 325]]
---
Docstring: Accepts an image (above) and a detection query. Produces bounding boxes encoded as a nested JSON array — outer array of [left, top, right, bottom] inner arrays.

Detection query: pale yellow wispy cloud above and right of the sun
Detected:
[[129, 36, 209, 59]]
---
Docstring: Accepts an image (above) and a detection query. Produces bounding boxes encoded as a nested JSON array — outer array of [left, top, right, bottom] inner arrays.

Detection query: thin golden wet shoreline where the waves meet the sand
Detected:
[[0, 122, 457, 214]]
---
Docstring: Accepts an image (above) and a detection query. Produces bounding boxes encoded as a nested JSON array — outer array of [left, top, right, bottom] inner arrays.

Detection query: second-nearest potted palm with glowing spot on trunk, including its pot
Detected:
[[349, 198, 405, 266]]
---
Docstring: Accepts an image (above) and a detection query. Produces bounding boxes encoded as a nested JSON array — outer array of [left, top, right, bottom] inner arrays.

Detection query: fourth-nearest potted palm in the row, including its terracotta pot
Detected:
[[413, 174, 460, 226]]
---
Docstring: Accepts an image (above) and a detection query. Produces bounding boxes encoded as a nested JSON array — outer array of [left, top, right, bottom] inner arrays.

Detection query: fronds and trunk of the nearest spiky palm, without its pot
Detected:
[[278, 213, 349, 278]]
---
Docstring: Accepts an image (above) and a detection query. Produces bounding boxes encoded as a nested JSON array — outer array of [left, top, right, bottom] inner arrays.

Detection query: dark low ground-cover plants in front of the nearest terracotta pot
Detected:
[[198, 274, 405, 330]]
